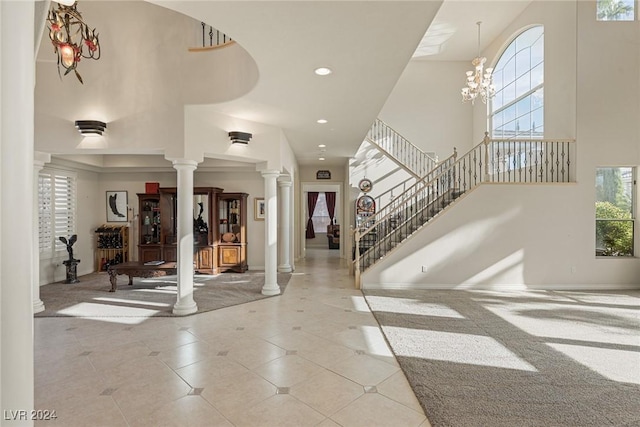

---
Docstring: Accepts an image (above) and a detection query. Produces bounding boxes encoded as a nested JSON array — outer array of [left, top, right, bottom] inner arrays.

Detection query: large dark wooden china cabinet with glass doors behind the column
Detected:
[[138, 187, 247, 274]]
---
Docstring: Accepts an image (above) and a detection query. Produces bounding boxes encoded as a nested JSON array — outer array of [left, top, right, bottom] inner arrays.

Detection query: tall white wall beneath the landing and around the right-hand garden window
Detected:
[[362, 1, 640, 289]]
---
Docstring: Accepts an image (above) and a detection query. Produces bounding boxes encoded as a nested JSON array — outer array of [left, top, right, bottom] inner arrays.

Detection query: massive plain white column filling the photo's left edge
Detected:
[[0, 1, 36, 426]]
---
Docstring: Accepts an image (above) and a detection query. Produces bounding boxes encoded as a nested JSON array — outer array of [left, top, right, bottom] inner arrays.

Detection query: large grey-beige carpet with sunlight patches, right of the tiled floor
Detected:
[[364, 290, 640, 427]]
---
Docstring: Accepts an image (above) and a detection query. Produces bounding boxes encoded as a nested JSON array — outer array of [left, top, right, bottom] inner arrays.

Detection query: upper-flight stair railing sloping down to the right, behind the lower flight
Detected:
[[366, 119, 438, 179]]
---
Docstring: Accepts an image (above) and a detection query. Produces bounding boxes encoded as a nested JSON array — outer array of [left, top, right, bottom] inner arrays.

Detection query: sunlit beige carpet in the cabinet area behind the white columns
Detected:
[[35, 271, 291, 317]]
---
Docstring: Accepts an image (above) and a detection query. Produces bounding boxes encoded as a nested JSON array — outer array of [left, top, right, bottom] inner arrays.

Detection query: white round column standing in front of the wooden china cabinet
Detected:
[[173, 159, 198, 316]]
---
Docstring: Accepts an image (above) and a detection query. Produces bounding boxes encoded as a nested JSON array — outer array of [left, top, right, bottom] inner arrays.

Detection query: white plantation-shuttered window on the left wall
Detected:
[[38, 168, 78, 259]]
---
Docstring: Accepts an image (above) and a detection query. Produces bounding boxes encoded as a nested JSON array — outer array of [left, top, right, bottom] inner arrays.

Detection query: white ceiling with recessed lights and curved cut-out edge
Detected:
[[39, 0, 531, 171]]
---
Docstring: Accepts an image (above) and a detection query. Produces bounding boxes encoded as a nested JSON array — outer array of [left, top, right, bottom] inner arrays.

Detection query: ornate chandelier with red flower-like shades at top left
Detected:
[[47, 0, 100, 83]]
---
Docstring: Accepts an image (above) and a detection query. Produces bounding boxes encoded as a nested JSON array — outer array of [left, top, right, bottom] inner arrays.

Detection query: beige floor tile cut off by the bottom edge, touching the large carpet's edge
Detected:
[[331, 393, 426, 427]]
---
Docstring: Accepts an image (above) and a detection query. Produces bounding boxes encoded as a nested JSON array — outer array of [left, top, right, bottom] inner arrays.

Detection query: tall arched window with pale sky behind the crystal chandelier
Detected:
[[490, 26, 544, 138]]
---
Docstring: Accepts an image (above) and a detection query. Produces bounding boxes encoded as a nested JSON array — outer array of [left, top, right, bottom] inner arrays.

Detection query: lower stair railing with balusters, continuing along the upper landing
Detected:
[[354, 133, 575, 287]]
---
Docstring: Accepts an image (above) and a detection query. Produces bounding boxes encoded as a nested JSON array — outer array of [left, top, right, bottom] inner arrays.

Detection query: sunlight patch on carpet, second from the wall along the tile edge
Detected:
[[383, 326, 537, 372]]
